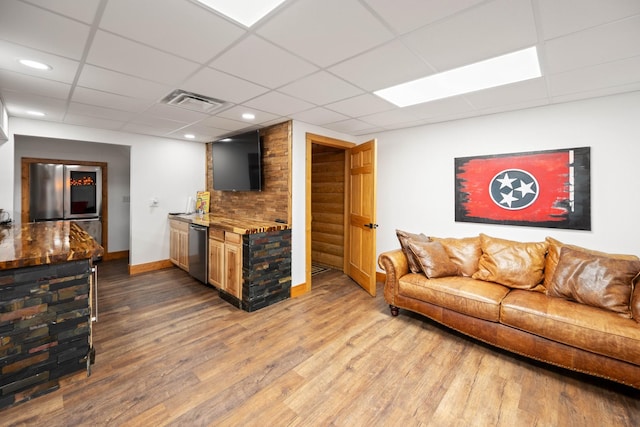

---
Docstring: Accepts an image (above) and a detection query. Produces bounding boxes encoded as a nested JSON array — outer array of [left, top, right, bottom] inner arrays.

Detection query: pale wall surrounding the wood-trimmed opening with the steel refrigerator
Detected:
[[13, 135, 130, 252]]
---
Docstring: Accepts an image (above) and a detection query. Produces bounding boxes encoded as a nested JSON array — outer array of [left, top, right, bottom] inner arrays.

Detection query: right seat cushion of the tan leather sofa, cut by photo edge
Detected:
[[500, 290, 640, 365]]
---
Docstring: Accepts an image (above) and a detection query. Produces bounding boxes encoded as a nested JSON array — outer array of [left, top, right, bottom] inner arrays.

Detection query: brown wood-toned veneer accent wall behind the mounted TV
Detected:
[[206, 121, 292, 224]]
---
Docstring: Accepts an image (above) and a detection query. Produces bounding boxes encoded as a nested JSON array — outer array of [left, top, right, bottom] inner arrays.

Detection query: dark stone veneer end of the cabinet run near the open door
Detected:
[[242, 229, 291, 311]]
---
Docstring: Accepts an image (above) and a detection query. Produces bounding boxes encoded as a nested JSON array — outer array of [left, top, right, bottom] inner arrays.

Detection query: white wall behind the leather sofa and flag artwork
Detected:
[[362, 92, 640, 264]]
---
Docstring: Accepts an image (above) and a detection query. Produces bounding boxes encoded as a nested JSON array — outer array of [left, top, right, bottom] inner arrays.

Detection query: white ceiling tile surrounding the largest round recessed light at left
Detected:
[[0, 40, 80, 83]]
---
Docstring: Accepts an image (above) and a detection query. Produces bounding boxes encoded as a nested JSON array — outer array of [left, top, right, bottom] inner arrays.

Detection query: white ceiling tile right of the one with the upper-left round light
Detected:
[[78, 65, 175, 100]]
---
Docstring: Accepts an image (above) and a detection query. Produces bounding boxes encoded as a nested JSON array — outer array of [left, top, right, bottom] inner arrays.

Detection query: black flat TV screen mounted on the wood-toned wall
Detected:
[[211, 130, 262, 191]]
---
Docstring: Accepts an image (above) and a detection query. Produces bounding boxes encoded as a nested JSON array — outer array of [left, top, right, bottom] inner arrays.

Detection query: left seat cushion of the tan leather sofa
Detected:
[[398, 274, 509, 322]]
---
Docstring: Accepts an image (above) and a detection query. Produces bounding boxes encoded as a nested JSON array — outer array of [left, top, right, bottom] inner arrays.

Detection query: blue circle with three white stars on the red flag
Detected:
[[489, 169, 540, 210]]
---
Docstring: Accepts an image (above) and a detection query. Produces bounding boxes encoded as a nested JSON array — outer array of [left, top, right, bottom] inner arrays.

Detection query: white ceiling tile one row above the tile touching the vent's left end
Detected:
[[87, 31, 198, 84]]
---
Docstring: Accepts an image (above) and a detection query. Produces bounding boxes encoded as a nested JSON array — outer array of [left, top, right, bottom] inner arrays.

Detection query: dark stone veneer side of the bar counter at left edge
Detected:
[[0, 260, 91, 408]]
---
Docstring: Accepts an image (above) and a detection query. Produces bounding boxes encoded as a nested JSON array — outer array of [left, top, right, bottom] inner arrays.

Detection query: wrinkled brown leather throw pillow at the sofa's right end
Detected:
[[547, 246, 640, 317]]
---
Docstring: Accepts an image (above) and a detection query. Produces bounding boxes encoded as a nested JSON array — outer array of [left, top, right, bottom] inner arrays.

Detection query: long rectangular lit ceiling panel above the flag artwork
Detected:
[[374, 46, 542, 107]]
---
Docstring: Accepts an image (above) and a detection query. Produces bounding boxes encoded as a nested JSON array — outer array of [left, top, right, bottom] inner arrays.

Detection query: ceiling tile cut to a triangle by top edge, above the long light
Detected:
[[365, 0, 484, 34]]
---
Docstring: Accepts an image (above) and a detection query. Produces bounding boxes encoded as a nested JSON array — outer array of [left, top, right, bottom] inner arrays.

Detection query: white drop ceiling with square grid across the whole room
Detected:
[[0, 0, 640, 142]]
